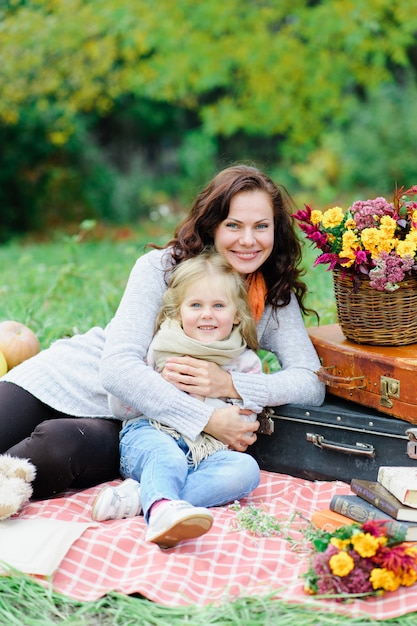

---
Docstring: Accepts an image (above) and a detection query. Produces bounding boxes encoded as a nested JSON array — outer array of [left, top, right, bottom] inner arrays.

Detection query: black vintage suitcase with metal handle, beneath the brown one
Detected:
[[249, 396, 417, 483]]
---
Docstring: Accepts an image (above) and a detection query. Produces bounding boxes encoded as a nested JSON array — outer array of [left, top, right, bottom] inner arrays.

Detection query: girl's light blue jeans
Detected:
[[120, 419, 260, 520]]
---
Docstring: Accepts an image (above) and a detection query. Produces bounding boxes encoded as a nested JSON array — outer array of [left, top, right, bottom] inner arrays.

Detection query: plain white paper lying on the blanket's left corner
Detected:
[[0, 517, 94, 576]]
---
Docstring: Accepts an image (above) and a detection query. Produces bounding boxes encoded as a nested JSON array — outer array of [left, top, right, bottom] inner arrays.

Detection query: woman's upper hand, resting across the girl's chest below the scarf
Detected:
[[162, 356, 240, 398]]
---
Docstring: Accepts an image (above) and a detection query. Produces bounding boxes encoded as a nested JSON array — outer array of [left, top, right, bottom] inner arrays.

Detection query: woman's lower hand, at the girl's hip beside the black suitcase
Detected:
[[204, 404, 259, 452]]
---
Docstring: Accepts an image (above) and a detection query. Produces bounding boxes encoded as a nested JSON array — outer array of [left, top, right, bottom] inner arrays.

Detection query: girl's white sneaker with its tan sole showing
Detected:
[[145, 500, 213, 548]]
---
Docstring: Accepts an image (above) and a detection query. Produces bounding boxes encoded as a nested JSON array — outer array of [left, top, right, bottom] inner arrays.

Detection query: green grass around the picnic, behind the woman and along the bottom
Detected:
[[0, 225, 416, 626]]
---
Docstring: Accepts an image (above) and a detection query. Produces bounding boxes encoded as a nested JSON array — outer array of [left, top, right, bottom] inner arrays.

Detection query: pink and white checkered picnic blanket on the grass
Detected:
[[8, 472, 417, 619]]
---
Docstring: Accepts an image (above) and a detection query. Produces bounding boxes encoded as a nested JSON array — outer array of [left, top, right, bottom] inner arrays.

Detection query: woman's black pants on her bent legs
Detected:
[[0, 381, 121, 499]]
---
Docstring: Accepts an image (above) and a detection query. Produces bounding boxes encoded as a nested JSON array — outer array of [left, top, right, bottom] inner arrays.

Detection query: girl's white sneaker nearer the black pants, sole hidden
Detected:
[[91, 478, 142, 522]]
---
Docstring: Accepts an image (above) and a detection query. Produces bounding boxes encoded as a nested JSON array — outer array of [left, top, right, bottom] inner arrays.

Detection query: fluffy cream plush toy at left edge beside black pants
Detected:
[[0, 454, 36, 520]]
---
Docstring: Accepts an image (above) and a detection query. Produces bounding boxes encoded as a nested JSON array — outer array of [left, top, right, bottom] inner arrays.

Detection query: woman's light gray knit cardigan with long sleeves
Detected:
[[1, 250, 325, 440]]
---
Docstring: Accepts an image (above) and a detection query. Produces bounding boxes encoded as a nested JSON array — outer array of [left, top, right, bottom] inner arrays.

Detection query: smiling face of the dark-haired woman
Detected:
[[214, 190, 274, 275]]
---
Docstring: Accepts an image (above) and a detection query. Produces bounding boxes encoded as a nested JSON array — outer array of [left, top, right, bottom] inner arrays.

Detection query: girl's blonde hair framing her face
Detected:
[[156, 248, 258, 350]]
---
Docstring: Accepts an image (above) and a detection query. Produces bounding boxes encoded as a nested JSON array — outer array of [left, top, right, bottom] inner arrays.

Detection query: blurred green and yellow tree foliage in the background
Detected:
[[0, 0, 417, 237]]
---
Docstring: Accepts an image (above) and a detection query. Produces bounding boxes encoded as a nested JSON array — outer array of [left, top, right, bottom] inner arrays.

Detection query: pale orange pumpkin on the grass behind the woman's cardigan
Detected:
[[0, 320, 41, 370]]
